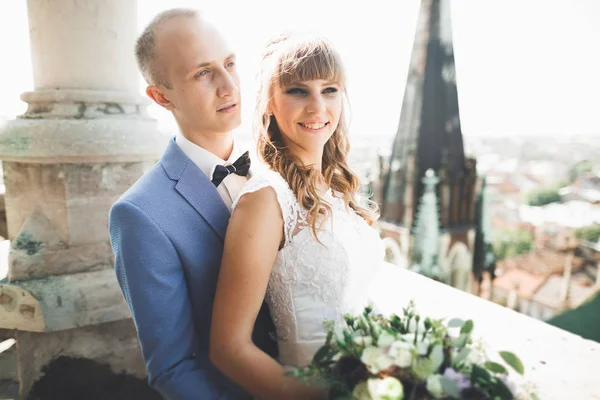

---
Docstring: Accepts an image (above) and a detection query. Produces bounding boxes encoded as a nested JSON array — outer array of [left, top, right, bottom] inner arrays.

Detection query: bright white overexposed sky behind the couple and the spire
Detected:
[[0, 0, 600, 136]]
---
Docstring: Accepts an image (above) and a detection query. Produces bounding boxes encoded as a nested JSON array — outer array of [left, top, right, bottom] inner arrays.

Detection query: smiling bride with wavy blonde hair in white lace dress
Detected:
[[210, 36, 384, 400]]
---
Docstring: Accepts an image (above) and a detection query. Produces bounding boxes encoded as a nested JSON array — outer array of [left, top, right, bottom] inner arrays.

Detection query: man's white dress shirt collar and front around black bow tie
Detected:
[[175, 132, 250, 212]]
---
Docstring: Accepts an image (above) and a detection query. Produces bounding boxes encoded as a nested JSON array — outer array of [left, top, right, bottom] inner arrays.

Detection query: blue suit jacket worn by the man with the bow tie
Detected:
[[109, 139, 276, 400]]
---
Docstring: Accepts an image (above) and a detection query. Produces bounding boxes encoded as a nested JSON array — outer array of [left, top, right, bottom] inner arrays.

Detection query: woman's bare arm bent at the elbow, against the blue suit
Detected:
[[210, 187, 327, 400]]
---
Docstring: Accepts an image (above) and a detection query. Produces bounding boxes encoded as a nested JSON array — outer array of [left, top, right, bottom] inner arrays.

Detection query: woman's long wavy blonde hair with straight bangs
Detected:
[[254, 35, 379, 240]]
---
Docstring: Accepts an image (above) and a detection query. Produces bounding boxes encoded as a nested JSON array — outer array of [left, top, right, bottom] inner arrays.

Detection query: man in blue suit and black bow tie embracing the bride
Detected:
[[109, 9, 276, 400]]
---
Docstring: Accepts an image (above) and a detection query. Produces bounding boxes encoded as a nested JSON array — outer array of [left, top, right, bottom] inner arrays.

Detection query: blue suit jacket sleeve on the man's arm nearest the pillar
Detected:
[[109, 201, 226, 400]]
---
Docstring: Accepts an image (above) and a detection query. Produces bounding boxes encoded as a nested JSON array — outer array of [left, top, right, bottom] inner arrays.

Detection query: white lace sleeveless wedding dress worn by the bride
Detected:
[[233, 170, 385, 366]]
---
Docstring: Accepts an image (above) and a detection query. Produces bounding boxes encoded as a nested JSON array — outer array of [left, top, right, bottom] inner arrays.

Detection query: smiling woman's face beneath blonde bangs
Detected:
[[269, 79, 342, 164]]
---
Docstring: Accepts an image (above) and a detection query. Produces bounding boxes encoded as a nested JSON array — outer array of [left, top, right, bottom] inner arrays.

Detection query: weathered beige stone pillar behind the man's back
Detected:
[[0, 0, 167, 397]]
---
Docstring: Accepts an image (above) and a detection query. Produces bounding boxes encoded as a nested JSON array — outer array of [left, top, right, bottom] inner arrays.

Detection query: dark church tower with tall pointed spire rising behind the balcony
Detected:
[[380, 0, 477, 291]]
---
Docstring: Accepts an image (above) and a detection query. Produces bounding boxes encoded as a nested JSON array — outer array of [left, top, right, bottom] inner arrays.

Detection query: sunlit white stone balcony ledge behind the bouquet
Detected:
[[374, 264, 600, 400]]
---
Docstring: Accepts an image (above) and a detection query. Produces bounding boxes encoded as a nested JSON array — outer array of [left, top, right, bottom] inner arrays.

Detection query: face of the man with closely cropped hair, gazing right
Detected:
[[156, 17, 241, 136]]
